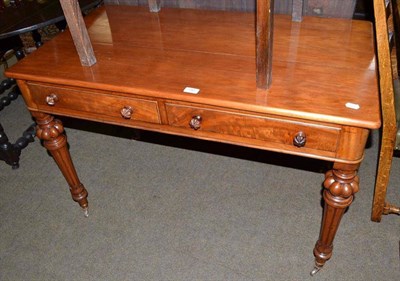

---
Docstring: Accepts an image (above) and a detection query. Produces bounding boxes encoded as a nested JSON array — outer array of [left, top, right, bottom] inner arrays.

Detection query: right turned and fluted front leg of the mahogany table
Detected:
[[311, 163, 359, 275]]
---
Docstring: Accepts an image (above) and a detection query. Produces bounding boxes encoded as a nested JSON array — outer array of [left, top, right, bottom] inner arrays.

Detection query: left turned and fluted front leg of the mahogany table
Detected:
[[32, 112, 89, 217]]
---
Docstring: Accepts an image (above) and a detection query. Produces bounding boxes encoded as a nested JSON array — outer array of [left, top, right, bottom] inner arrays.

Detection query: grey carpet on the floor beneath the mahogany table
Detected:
[[0, 55, 400, 281]]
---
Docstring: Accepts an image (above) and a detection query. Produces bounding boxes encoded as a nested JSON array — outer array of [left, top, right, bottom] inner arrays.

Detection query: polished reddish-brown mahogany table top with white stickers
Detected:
[[6, 6, 380, 128]]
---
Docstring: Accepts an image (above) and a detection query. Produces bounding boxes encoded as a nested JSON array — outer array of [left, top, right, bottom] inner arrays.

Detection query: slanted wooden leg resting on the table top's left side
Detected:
[[60, 0, 96, 66]]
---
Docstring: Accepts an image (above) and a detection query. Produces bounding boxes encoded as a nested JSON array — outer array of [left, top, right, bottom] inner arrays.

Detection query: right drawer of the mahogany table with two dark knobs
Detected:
[[166, 104, 341, 152]]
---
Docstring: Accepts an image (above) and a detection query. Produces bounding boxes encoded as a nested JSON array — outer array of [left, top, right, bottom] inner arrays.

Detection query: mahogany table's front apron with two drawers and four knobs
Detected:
[[19, 82, 368, 163]]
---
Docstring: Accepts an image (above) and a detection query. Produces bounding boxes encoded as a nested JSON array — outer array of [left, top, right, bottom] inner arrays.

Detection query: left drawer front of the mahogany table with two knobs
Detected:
[[29, 84, 161, 124]]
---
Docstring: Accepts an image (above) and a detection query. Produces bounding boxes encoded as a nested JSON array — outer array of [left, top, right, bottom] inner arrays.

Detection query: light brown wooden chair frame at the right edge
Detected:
[[371, 0, 400, 222]]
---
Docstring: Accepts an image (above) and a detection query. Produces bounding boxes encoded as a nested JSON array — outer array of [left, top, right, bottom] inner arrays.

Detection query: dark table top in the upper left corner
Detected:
[[0, 0, 102, 39]]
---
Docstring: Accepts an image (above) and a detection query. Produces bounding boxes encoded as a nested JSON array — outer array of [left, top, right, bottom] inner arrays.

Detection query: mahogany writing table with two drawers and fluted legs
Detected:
[[6, 6, 380, 274]]
